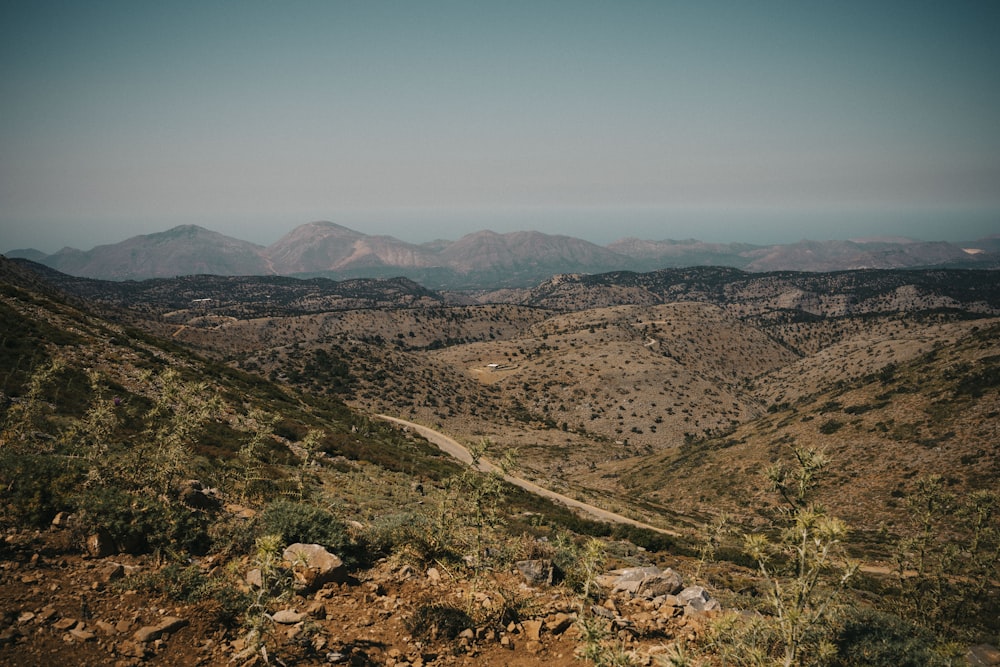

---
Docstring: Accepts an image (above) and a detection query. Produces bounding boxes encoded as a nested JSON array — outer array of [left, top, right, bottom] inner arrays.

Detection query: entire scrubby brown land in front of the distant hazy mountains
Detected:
[[0, 253, 1000, 665]]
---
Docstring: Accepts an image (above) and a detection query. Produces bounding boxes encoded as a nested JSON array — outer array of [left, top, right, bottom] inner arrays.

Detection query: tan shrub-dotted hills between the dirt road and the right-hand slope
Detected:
[[66, 267, 1000, 536]]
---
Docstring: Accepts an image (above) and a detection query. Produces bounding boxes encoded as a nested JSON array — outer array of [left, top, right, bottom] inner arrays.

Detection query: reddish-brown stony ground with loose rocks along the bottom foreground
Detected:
[[0, 528, 718, 667]]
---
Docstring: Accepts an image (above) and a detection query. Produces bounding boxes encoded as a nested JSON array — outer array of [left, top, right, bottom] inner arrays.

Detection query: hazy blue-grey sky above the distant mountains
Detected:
[[0, 0, 1000, 252]]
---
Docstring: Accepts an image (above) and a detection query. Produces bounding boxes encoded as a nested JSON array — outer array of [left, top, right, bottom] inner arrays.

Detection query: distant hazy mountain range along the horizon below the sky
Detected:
[[6, 222, 1000, 289]]
